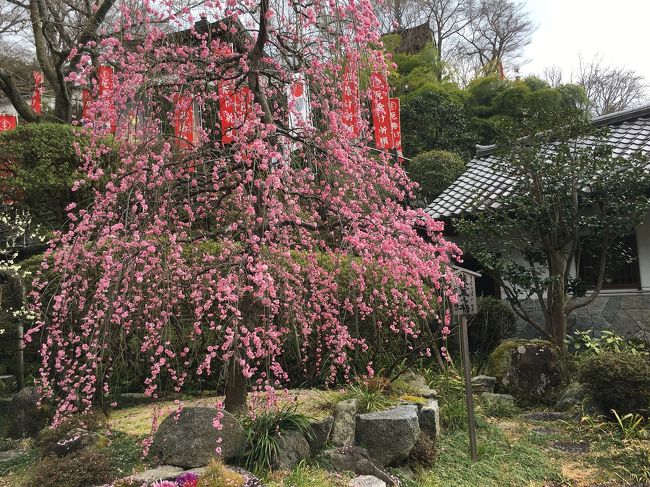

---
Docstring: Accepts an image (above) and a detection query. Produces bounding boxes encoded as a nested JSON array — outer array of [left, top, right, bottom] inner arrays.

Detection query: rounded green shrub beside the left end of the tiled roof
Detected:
[[409, 150, 465, 204]]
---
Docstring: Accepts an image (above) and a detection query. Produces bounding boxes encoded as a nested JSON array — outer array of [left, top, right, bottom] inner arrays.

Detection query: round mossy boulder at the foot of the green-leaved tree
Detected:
[[487, 340, 563, 405]]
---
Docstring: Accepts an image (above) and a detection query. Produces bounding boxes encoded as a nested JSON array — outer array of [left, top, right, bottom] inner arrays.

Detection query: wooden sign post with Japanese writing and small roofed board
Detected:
[[453, 267, 481, 462]]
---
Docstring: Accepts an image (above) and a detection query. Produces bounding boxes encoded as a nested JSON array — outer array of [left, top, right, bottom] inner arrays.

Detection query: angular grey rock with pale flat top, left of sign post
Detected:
[[356, 404, 420, 465]]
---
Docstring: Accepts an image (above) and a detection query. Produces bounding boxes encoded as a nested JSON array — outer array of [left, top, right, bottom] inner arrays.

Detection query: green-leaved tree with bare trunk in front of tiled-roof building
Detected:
[[455, 106, 650, 351]]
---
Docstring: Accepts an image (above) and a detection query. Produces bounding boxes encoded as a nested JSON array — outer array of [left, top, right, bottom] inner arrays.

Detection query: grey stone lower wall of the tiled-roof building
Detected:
[[517, 293, 650, 341]]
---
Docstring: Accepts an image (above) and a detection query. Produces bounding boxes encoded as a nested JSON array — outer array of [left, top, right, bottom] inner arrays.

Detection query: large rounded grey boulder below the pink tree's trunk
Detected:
[[150, 407, 246, 468]]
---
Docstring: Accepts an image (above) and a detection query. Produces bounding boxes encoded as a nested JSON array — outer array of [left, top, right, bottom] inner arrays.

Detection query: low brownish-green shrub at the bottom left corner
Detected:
[[25, 449, 114, 487]]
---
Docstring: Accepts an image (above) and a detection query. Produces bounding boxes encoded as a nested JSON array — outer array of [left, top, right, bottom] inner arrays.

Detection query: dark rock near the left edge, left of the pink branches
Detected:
[[7, 387, 52, 438]]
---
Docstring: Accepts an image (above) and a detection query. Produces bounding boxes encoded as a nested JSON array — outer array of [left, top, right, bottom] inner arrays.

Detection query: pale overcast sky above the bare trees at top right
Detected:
[[521, 0, 650, 81]]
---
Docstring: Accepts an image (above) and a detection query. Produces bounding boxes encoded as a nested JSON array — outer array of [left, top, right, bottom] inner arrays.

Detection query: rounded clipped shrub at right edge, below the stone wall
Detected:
[[579, 352, 650, 414]]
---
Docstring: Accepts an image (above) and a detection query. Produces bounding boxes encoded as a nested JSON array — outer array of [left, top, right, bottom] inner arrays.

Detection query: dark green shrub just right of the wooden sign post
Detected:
[[467, 297, 517, 365]]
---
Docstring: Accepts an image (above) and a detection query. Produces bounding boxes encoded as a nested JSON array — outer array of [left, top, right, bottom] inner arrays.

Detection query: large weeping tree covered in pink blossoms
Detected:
[[29, 0, 460, 417]]
